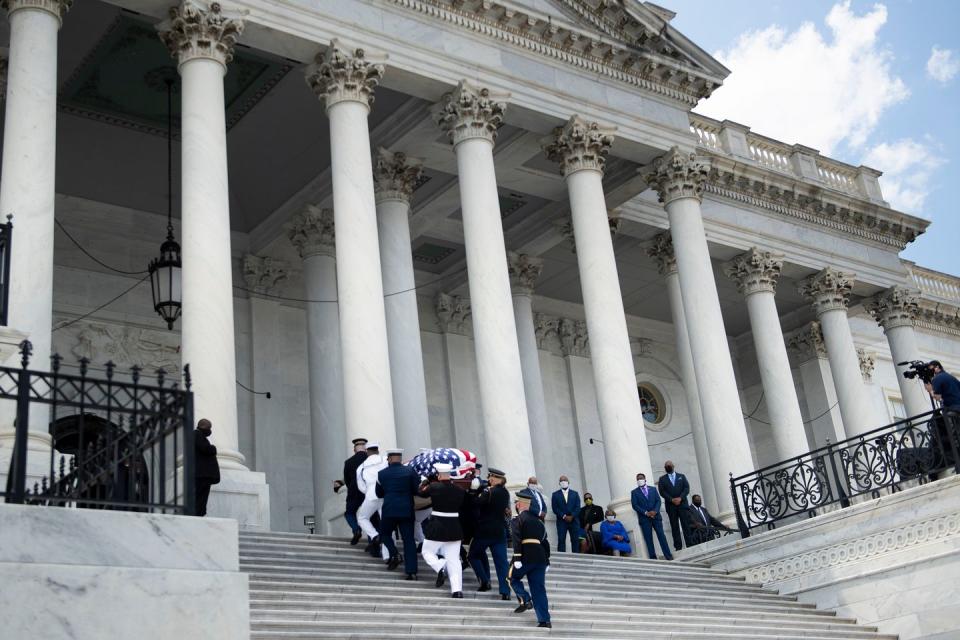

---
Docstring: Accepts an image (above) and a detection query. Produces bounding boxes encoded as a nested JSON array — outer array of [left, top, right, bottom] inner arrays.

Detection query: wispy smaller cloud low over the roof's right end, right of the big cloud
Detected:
[[863, 138, 945, 214]]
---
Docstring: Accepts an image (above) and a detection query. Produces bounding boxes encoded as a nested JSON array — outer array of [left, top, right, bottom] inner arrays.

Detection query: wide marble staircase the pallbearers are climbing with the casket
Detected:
[[240, 532, 896, 640]]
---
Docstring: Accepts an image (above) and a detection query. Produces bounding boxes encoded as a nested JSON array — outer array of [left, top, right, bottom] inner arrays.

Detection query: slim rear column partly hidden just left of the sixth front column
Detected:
[[647, 231, 725, 508]]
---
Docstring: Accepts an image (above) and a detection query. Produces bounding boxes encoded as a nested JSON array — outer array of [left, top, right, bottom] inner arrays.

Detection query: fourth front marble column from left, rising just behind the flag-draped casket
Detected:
[[435, 81, 534, 485]]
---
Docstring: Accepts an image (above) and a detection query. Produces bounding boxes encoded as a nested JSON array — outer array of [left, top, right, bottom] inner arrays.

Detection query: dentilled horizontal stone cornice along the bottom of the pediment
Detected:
[[384, 0, 723, 107]]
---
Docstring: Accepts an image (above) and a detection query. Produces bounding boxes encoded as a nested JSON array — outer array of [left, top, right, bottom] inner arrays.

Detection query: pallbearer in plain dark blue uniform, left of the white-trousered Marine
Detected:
[[376, 449, 420, 580]]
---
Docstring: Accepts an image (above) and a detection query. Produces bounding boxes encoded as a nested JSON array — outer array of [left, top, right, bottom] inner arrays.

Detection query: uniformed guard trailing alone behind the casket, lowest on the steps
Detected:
[[510, 489, 553, 628]]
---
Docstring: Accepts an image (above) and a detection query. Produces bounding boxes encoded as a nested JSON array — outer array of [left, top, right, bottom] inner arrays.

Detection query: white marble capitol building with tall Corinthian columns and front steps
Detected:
[[0, 0, 960, 640]]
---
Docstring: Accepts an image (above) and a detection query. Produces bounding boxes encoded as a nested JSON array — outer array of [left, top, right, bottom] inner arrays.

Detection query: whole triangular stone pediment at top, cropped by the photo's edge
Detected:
[[393, 0, 730, 106]]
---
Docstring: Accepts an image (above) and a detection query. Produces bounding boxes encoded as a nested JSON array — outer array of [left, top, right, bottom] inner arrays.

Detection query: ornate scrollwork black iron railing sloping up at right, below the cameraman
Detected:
[[730, 409, 960, 537]]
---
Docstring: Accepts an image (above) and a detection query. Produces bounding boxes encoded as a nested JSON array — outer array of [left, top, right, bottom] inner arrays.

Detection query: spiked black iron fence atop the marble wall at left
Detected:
[[0, 341, 195, 515]]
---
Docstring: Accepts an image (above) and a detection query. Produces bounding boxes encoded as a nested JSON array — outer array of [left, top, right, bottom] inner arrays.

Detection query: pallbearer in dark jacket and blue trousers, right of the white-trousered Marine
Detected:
[[467, 467, 510, 600]]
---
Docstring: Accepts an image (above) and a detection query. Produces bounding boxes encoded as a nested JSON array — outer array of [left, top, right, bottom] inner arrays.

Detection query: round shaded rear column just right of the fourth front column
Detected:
[[507, 251, 552, 488]]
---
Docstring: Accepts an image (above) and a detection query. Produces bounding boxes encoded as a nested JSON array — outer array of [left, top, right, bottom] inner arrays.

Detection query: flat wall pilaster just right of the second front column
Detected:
[[241, 254, 286, 531]]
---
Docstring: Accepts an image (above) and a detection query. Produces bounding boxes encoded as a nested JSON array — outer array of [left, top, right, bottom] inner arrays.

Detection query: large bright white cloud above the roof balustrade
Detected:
[[697, 0, 909, 155]]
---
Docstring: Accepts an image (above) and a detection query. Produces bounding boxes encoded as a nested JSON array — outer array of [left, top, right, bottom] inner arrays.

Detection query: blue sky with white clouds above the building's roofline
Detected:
[[659, 0, 960, 275]]
